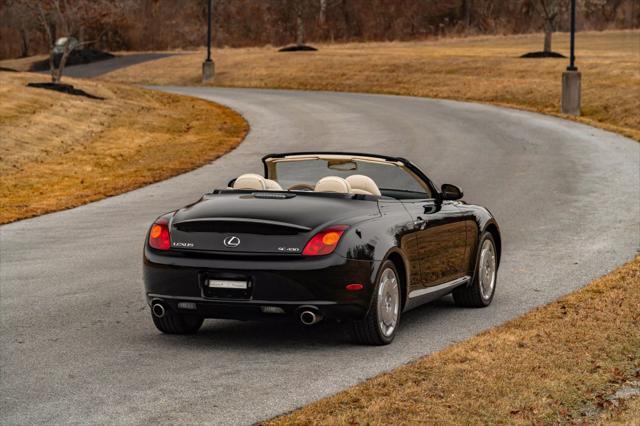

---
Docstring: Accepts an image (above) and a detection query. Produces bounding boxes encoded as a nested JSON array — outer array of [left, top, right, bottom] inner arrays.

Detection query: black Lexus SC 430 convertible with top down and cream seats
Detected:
[[144, 152, 501, 345]]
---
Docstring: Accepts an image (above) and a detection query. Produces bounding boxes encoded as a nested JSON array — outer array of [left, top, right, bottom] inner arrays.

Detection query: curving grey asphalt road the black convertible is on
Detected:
[[0, 88, 640, 425]]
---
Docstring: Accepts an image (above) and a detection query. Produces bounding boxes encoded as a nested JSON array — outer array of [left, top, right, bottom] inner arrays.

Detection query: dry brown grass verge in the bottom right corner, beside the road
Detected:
[[267, 257, 640, 425]]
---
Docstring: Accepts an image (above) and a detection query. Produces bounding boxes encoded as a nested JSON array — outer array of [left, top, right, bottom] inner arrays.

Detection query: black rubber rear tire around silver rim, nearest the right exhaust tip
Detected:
[[350, 260, 402, 346]]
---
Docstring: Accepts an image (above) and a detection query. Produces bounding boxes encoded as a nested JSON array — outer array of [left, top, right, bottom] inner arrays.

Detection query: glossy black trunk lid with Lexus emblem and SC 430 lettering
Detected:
[[171, 192, 379, 255]]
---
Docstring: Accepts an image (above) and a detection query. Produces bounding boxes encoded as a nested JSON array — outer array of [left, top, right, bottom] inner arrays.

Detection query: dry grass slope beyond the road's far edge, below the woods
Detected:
[[104, 31, 640, 140]]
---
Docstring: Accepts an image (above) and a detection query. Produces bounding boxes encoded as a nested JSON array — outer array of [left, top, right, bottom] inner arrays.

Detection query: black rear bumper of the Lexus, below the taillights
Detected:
[[143, 247, 379, 319]]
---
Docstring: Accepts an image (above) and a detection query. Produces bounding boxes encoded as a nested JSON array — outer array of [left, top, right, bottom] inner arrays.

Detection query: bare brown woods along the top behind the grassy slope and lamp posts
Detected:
[[0, 0, 640, 58]]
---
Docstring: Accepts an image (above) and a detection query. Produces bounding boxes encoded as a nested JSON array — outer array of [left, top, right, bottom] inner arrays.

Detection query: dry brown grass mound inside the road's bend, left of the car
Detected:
[[0, 72, 248, 223]]
